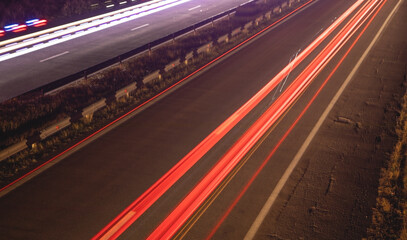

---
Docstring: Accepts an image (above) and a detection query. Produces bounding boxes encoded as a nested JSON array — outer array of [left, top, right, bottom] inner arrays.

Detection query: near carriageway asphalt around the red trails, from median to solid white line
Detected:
[[0, 0, 391, 239]]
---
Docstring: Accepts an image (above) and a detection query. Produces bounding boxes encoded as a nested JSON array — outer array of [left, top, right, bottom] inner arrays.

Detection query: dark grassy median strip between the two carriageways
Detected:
[[0, 1, 295, 185]]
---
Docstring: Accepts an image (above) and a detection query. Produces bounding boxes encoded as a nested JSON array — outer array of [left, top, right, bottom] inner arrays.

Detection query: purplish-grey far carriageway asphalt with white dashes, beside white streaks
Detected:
[[0, 0, 252, 101]]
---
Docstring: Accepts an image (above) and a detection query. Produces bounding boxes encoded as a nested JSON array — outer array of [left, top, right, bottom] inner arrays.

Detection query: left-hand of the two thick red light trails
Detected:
[[93, 1, 368, 239]]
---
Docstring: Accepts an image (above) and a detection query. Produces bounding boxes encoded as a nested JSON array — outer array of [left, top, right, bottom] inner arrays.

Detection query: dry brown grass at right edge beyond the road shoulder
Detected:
[[368, 91, 407, 239]]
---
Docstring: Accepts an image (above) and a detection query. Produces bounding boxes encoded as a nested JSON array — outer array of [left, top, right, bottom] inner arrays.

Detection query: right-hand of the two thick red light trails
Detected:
[[148, 1, 386, 239]]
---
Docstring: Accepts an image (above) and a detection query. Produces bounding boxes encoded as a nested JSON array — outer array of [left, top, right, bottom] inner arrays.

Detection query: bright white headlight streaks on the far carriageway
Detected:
[[0, 0, 190, 62]]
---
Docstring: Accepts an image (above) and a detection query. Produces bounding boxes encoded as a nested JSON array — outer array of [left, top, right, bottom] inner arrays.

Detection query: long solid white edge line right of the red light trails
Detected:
[[244, 0, 404, 240]]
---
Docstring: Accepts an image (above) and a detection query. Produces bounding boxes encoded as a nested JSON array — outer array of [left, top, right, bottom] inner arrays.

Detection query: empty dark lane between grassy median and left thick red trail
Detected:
[[0, 0, 362, 239]]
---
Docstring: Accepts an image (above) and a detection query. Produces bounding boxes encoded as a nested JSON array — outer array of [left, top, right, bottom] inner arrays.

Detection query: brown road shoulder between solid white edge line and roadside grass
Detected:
[[257, 1, 407, 239]]
